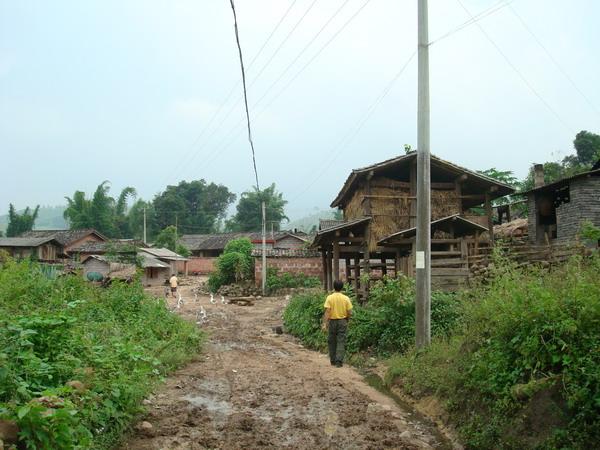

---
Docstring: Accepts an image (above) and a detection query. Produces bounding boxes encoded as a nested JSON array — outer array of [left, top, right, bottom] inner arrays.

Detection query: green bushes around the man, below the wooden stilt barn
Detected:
[[284, 277, 461, 354]]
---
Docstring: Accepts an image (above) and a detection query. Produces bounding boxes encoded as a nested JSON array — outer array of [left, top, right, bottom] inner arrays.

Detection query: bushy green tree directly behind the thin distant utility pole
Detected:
[[227, 183, 289, 231]]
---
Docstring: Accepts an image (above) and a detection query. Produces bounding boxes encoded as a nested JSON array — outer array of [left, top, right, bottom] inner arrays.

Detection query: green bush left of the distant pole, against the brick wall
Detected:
[[208, 238, 254, 292]]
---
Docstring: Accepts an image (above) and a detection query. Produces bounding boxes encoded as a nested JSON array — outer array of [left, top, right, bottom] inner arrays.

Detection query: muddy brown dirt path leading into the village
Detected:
[[122, 287, 447, 450]]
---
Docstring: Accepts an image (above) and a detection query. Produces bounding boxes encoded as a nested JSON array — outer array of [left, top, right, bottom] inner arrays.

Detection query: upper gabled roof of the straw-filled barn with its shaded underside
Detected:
[[331, 152, 515, 208]]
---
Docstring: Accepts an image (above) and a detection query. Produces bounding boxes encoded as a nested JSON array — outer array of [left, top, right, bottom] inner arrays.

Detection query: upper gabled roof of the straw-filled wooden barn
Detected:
[[331, 152, 515, 208]]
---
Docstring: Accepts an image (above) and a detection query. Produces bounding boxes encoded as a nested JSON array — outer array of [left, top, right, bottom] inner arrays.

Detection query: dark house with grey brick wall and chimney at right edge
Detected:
[[524, 160, 600, 244]]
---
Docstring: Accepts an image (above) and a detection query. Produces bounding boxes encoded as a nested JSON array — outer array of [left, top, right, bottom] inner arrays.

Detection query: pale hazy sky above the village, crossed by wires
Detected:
[[0, 0, 600, 218]]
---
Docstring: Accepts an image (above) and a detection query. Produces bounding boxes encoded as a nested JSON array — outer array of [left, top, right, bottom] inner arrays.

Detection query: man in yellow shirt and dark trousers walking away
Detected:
[[323, 280, 352, 367]]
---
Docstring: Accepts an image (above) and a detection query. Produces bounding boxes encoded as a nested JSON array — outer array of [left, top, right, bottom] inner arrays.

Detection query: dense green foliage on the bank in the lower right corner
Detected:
[[390, 256, 600, 448]]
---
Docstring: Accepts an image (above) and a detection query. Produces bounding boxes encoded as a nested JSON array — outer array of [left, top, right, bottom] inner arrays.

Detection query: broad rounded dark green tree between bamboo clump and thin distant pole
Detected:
[[152, 180, 235, 233]]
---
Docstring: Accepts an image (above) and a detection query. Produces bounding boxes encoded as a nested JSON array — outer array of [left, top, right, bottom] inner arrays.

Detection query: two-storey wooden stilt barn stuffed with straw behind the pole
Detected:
[[313, 152, 514, 297]]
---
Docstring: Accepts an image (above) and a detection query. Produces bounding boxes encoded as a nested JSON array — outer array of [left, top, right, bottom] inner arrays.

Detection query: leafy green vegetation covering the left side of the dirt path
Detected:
[[0, 256, 202, 449]]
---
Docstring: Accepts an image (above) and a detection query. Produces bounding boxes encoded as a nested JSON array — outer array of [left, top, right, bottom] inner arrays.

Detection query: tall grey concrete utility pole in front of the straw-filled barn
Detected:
[[415, 0, 431, 348]]
